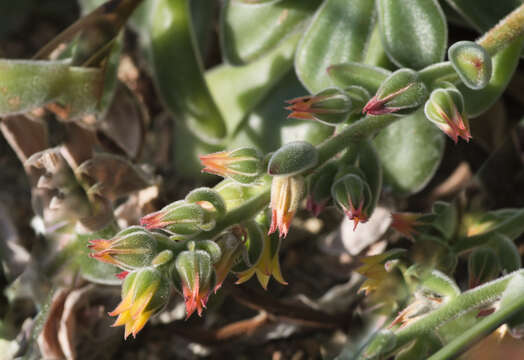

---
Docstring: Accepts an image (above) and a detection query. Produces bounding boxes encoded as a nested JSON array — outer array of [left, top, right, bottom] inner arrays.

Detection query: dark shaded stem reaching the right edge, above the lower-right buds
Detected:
[[453, 209, 524, 253]]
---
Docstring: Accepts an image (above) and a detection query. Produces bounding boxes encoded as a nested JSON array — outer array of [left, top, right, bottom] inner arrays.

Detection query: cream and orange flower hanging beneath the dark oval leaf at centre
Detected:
[[269, 175, 304, 237]]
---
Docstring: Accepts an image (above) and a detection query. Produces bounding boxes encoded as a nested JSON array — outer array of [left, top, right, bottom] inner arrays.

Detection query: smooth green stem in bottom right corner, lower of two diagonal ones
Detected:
[[428, 274, 524, 360]]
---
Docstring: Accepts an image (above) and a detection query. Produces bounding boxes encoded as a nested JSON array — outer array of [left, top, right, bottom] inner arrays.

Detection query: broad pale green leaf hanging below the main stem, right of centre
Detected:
[[374, 109, 445, 195]]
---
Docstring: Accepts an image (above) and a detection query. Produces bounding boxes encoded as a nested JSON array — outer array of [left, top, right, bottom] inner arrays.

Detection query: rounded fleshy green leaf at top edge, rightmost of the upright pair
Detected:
[[377, 0, 448, 70]]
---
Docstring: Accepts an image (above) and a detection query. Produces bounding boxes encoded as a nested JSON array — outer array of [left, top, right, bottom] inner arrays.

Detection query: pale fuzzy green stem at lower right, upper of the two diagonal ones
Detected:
[[395, 270, 524, 349]]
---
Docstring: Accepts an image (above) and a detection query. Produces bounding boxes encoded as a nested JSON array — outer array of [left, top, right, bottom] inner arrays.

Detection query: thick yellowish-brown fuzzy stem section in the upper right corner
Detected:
[[477, 4, 524, 56]]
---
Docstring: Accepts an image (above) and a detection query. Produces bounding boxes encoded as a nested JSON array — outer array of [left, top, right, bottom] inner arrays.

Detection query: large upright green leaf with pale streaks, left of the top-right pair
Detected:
[[295, 0, 375, 93]]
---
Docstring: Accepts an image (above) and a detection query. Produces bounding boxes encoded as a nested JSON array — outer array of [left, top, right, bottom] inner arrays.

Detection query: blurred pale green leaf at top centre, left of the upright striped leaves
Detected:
[[220, 0, 320, 65]]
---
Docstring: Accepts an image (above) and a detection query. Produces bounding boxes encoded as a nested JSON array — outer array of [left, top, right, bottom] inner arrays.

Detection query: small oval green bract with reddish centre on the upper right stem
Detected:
[[448, 41, 493, 90]]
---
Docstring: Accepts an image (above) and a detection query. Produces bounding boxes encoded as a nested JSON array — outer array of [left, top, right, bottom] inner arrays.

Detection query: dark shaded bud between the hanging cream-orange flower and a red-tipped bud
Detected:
[[306, 162, 337, 216]]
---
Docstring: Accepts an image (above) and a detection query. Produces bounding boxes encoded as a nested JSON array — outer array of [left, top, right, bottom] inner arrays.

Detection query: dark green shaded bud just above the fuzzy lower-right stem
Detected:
[[468, 247, 500, 289]]
